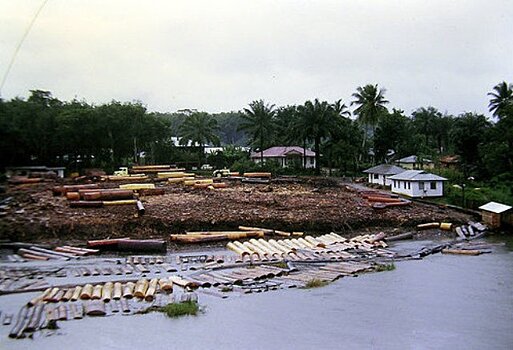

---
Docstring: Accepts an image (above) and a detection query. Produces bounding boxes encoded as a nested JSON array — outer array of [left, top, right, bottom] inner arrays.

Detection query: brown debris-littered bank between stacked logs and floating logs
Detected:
[[0, 181, 468, 241]]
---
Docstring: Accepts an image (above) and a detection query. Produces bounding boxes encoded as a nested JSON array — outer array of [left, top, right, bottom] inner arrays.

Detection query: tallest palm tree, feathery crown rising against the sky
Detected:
[[351, 84, 388, 158]]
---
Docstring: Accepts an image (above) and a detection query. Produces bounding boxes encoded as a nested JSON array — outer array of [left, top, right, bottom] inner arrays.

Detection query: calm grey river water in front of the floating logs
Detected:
[[0, 238, 513, 350]]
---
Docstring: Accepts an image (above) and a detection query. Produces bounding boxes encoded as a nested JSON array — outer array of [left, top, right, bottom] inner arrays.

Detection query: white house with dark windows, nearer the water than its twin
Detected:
[[389, 170, 447, 198]]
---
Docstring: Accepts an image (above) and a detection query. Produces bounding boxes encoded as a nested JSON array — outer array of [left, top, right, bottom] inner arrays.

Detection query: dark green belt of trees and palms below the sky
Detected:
[[0, 82, 513, 185]]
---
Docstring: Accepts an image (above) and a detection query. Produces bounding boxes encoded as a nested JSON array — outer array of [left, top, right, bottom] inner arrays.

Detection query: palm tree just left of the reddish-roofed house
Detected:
[[239, 100, 276, 166]]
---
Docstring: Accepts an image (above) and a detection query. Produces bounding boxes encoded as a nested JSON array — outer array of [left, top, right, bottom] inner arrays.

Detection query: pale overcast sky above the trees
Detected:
[[0, 0, 513, 115]]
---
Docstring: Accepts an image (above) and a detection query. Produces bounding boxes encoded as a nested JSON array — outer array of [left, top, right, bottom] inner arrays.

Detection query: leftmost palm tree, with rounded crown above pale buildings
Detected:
[[179, 112, 220, 163]]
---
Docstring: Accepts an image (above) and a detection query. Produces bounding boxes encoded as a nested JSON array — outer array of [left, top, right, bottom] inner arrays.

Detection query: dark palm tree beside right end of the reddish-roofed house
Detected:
[[296, 99, 347, 175]]
